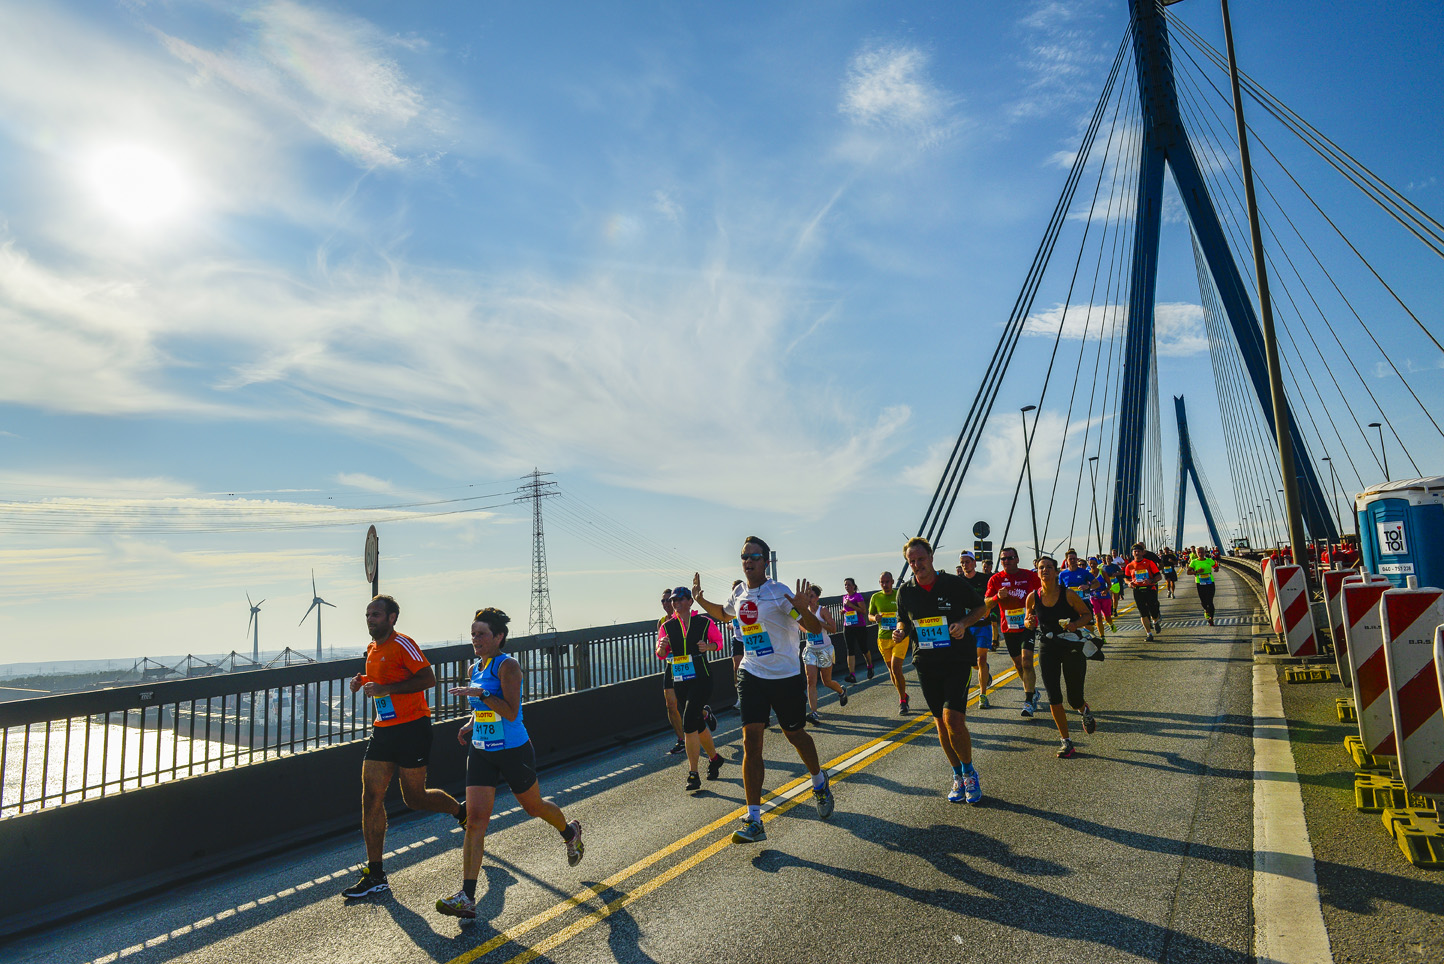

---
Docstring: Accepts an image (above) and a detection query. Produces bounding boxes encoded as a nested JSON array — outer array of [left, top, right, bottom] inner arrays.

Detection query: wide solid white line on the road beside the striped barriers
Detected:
[[1253, 664, 1334, 964]]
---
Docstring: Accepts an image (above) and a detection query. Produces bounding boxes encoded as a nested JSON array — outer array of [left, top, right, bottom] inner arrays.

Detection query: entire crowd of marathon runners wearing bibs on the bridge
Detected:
[[342, 535, 1219, 918]]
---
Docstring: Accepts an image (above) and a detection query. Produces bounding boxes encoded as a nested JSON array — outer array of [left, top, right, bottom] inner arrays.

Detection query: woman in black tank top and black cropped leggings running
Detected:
[[1028, 556, 1096, 758]]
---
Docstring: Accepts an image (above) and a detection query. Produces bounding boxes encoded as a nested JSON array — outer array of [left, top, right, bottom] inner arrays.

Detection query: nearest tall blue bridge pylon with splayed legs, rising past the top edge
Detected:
[[1110, 0, 1339, 548]]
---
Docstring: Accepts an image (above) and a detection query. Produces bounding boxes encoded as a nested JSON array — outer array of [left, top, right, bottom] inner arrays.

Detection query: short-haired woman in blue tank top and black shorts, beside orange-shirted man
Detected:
[[436, 608, 583, 919]]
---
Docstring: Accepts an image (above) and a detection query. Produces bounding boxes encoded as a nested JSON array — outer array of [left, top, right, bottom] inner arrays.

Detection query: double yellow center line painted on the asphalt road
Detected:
[[448, 670, 1018, 964]]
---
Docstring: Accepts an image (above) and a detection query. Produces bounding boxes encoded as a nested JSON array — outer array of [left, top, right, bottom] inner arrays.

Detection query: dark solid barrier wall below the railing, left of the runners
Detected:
[[0, 658, 736, 937]]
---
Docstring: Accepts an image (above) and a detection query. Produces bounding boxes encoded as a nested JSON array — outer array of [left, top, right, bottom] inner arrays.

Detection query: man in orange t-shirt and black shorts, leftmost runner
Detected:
[[341, 596, 466, 898]]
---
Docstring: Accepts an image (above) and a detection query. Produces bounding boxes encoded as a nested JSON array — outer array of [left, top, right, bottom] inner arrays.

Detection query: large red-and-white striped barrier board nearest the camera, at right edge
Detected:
[[1379, 589, 1444, 797]]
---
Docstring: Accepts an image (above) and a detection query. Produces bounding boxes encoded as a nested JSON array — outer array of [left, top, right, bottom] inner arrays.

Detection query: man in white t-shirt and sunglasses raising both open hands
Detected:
[[692, 535, 833, 843]]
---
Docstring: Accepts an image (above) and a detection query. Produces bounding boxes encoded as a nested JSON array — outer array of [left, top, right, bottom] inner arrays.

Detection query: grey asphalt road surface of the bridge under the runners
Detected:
[[14, 574, 1444, 964]]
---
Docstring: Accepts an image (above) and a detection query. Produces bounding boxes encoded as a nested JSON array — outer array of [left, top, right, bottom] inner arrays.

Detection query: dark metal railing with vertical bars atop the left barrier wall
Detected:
[[0, 597, 838, 818]]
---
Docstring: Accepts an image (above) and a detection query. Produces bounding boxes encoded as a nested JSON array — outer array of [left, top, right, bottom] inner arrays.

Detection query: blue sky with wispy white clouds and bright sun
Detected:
[[0, 0, 1444, 661]]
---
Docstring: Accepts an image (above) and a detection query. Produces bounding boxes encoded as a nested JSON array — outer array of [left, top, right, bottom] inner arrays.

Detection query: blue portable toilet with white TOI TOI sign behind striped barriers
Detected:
[[1354, 476, 1444, 589]]
